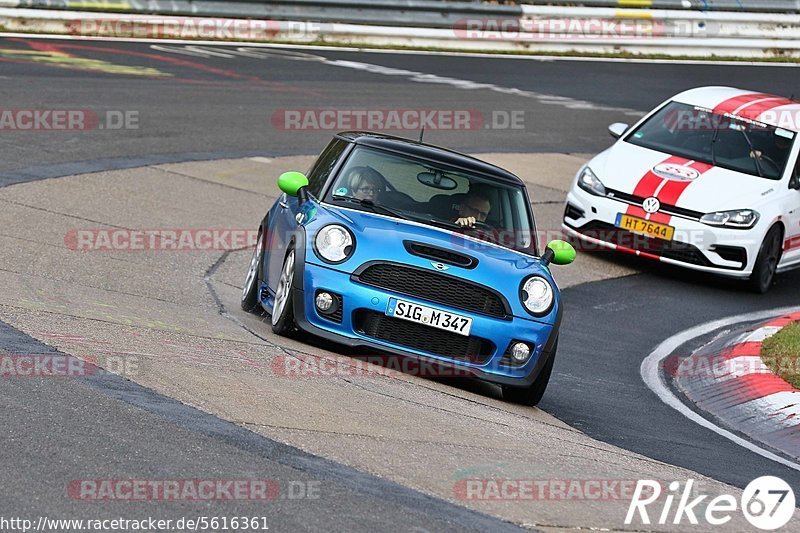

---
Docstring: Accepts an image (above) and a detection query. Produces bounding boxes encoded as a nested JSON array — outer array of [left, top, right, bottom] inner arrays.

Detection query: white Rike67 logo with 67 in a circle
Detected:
[[625, 476, 795, 531]]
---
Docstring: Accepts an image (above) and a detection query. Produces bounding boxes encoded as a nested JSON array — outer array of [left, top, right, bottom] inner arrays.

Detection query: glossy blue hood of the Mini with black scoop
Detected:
[[306, 204, 558, 322]]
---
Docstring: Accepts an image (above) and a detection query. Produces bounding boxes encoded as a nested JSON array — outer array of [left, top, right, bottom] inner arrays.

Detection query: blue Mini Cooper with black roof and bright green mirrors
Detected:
[[241, 132, 575, 405]]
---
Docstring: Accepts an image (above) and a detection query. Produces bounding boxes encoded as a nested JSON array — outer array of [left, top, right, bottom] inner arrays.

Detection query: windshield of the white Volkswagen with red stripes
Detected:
[[625, 102, 796, 180]]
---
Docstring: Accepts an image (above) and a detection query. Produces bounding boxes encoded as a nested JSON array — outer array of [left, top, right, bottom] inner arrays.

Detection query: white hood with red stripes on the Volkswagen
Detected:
[[590, 142, 777, 213]]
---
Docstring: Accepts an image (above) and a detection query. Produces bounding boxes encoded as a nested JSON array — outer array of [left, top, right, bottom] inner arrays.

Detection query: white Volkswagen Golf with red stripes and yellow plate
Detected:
[[563, 87, 800, 293]]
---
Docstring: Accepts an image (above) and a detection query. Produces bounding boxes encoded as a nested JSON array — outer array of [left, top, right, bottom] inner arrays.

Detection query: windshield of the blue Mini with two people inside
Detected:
[[325, 147, 535, 254]]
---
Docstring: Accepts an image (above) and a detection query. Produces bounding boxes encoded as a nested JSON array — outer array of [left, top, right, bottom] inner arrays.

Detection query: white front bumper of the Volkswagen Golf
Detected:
[[562, 187, 763, 279]]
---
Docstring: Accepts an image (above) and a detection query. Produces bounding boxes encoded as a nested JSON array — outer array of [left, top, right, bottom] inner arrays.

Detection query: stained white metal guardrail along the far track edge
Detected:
[[0, 0, 800, 58]]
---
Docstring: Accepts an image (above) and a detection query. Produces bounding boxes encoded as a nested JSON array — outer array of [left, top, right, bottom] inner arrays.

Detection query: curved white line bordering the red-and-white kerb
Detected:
[[639, 307, 800, 471]]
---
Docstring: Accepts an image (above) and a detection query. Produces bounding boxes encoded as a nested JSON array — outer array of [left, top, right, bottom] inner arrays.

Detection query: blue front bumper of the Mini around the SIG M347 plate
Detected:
[[293, 263, 559, 386]]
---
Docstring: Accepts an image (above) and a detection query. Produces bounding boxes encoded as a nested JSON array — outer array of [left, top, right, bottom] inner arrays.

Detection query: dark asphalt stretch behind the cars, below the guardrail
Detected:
[[6, 39, 796, 175]]
